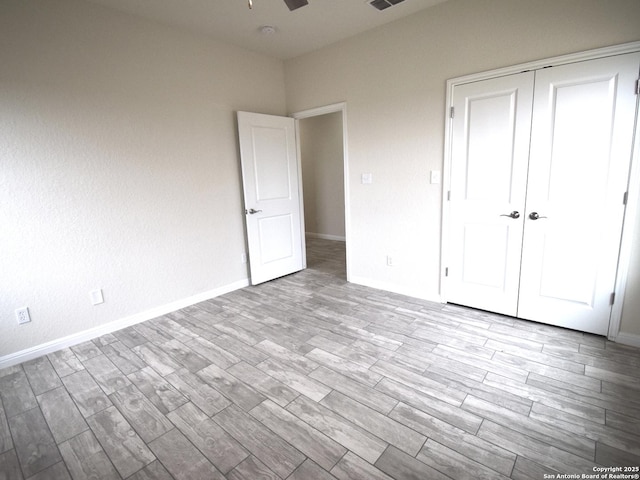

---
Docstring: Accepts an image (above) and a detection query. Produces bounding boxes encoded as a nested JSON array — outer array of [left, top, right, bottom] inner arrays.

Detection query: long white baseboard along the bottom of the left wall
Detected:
[[0, 280, 249, 370]]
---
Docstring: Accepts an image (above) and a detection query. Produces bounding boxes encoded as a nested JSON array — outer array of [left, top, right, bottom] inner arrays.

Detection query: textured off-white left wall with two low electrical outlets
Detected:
[[0, 0, 285, 358]]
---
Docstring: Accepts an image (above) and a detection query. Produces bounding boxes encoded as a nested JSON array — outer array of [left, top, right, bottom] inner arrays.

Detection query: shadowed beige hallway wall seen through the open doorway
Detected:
[[298, 112, 345, 239]]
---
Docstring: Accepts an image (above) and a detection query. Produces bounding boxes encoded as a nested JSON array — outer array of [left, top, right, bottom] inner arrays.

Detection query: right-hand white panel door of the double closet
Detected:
[[518, 54, 640, 335]]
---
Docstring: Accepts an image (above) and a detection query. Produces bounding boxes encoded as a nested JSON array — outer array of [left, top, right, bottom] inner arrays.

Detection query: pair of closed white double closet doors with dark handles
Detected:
[[445, 53, 640, 335]]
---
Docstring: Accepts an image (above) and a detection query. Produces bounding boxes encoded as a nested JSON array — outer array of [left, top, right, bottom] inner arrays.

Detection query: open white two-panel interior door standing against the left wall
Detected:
[[238, 112, 305, 285]]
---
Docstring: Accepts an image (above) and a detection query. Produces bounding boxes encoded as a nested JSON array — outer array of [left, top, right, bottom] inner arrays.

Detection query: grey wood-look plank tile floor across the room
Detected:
[[0, 239, 640, 480]]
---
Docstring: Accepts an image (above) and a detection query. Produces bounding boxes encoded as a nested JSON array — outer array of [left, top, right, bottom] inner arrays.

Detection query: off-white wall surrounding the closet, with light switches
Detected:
[[285, 0, 640, 333]]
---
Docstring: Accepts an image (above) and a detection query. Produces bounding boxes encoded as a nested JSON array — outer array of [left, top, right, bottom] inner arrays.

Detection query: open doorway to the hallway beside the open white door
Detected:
[[293, 104, 349, 281]]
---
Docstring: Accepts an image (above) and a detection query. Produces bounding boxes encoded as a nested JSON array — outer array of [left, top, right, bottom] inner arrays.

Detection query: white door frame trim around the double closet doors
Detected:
[[440, 42, 640, 341]]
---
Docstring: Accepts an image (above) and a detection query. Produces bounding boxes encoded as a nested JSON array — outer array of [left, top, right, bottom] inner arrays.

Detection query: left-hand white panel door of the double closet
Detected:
[[447, 72, 534, 315]]
